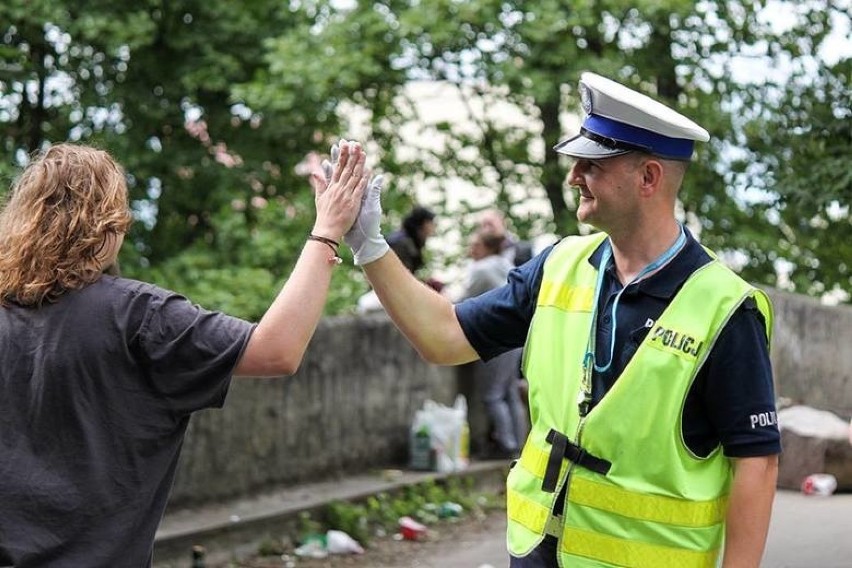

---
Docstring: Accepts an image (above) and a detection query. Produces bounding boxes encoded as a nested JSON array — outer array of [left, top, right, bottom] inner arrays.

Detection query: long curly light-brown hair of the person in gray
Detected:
[[0, 144, 132, 306]]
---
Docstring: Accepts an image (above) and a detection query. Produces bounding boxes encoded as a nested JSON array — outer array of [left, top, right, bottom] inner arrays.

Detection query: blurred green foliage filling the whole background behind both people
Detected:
[[0, 0, 852, 308]]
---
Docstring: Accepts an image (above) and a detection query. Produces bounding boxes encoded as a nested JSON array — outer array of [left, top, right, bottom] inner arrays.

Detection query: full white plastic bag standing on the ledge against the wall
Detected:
[[410, 395, 470, 473]]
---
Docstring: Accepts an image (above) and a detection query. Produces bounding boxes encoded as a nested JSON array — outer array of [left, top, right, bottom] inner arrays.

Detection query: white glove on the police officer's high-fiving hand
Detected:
[[322, 140, 390, 266]]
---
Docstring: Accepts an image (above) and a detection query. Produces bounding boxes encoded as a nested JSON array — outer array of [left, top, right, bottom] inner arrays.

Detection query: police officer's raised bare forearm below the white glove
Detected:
[[363, 252, 478, 365]]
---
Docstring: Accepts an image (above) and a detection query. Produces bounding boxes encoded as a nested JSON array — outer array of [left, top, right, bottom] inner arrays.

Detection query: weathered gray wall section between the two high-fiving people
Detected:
[[170, 314, 457, 507]]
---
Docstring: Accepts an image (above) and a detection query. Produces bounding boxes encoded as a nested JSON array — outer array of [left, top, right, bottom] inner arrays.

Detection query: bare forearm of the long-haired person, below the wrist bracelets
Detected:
[[234, 240, 336, 377]]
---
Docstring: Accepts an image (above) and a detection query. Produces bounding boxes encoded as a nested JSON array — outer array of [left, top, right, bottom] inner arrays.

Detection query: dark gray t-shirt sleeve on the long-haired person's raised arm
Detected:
[[128, 289, 254, 414]]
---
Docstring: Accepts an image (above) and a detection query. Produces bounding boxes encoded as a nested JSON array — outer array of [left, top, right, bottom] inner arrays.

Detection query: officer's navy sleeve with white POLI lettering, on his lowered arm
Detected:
[[704, 299, 781, 457]]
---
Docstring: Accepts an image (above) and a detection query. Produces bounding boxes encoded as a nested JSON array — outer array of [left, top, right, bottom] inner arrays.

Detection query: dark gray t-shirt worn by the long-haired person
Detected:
[[0, 276, 254, 568]]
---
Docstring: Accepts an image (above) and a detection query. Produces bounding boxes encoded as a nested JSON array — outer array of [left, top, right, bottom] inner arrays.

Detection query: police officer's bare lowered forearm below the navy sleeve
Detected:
[[722, 456, 778, 568]]
